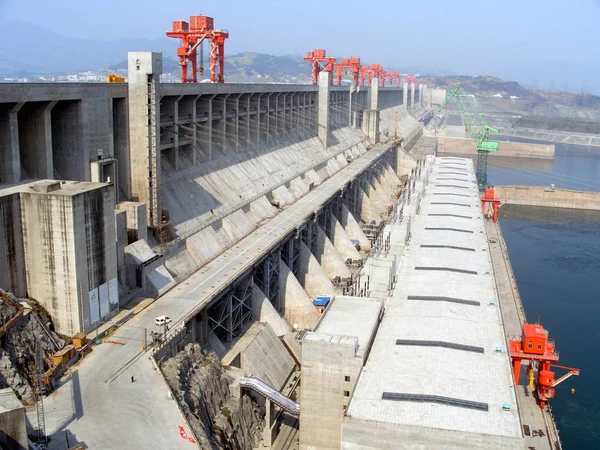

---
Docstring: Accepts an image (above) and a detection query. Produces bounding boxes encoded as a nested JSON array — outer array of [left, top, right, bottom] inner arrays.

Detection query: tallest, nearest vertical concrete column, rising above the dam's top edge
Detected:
[[127, 52, 162, 226]]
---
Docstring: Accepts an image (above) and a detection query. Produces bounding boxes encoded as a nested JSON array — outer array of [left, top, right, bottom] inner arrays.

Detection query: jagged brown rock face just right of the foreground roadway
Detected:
[[161, 343, 264, 450]]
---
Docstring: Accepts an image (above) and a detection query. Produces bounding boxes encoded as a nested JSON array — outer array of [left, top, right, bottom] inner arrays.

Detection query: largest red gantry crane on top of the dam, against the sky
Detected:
[[167, 16, 229, 83]]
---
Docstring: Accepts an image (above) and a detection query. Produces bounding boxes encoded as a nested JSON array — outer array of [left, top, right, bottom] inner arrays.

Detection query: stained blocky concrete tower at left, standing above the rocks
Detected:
[[21, 182, 118, 336]]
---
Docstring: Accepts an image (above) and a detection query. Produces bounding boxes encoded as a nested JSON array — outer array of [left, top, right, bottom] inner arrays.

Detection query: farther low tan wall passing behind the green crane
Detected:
[[438, 138, 555, 159]]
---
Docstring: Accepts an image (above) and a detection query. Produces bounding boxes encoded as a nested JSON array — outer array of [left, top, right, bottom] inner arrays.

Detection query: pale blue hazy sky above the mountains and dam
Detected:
[[0, 0, 600, 89]]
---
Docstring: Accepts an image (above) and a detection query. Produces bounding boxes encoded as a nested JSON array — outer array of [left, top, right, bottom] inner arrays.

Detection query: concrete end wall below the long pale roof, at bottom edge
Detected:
[[338, 416, 524, 450]]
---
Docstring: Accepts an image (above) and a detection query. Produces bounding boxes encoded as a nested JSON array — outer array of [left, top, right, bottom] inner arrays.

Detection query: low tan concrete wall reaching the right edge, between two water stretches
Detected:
[[494, 186, 600, 210]]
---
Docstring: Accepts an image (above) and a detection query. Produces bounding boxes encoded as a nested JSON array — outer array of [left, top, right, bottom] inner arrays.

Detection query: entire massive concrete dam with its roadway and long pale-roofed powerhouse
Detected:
[[0, 52, 560, 450]]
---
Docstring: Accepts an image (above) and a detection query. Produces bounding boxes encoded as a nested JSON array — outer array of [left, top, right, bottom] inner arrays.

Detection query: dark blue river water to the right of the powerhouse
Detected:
[[488, 140, 600, 450]]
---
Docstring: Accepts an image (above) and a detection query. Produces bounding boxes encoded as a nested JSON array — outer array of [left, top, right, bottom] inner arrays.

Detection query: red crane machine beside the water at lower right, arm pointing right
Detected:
[[509, 324, 579, 408]]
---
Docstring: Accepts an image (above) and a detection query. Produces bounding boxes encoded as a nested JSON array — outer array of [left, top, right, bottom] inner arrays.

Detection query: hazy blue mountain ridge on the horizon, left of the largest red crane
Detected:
[[0, 22, 177, 76]]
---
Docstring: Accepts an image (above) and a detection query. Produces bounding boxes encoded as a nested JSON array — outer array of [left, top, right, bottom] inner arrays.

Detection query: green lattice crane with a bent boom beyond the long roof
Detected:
[[439, 86, 500, 189]]
